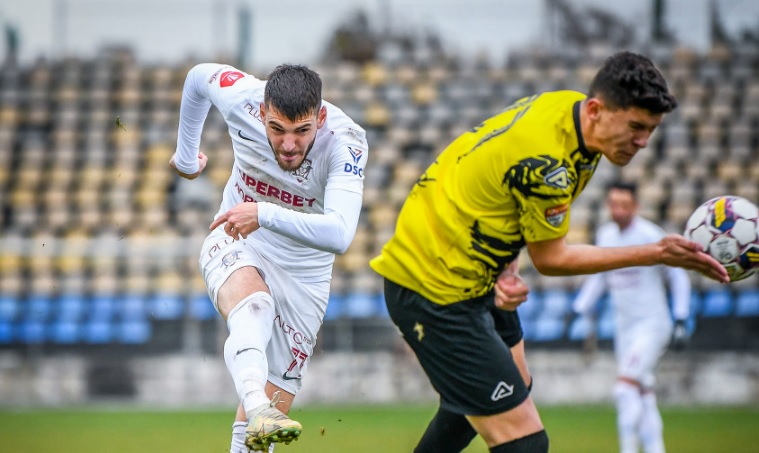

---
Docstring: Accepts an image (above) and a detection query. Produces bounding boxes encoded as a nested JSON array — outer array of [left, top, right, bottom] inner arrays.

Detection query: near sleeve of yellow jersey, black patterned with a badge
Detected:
[[505, 154, 572, 242]]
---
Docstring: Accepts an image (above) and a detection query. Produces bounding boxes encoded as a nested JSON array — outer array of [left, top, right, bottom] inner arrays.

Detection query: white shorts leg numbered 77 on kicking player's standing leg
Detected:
[[264, 262, 330, 395]]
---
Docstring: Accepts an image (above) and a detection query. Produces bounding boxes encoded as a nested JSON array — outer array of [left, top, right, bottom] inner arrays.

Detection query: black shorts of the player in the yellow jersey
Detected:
[[385, 279, 529, 415]]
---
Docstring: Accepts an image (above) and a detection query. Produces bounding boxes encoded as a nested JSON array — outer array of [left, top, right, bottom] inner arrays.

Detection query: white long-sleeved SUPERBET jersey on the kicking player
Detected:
[[175, 64, 368, 281]]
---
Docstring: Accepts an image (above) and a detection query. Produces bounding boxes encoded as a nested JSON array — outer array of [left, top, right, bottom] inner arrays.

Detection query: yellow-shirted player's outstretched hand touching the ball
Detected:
[[658, 234, 730, 283]]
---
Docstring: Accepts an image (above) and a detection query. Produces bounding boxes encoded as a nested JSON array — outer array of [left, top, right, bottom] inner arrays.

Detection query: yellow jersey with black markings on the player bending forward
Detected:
[[371, 91, 601, 305]]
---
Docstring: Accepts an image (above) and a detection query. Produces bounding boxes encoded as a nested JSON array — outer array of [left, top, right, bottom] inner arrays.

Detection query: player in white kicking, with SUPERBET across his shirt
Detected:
[[169, 63, 368, 453]]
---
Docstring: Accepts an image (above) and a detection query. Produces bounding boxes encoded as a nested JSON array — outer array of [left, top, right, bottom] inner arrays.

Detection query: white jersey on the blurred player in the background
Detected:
[[574, 217, 690, 325]]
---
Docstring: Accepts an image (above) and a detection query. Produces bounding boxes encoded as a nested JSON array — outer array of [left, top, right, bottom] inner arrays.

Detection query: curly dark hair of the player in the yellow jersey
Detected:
[[588, 52, 677, 113]]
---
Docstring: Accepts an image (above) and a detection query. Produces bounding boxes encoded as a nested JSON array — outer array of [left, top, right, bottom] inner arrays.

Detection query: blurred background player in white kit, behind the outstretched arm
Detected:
[[574, 182, 691, 453]]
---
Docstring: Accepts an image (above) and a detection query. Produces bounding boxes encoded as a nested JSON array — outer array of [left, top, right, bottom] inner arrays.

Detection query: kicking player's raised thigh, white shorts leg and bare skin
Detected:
[[199, 228, 269, 319]]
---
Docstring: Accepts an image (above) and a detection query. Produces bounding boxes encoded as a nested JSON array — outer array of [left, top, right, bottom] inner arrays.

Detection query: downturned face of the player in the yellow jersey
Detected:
[[586, 99, 664, 166]]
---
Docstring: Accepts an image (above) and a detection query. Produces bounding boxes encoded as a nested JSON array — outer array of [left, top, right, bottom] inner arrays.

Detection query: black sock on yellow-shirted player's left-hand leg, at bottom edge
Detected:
[[414, 408, 477, 453]]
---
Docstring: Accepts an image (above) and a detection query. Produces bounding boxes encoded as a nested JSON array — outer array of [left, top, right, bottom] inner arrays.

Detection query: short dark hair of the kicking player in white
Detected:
[[264, 64, 322, 121]]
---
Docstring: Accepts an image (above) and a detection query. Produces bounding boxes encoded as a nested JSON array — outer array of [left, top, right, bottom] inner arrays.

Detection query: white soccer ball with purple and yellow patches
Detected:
[[684, 195, 759, 282]]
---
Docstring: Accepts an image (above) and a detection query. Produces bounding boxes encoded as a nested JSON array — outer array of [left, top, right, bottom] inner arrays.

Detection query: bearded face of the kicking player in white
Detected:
[[261, 103, 327, 171]]
